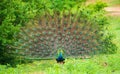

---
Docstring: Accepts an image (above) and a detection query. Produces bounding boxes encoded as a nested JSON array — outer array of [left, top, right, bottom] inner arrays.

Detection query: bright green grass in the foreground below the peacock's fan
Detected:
[[0, 54, 120, 74]]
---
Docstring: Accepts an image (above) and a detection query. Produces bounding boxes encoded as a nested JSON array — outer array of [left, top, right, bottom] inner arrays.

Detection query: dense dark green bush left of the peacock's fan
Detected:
[[0, 0, 36, 64]]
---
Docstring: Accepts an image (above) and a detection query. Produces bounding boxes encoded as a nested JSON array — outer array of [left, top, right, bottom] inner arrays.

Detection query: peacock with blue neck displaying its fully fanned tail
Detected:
[[12, 12, 102, 62]]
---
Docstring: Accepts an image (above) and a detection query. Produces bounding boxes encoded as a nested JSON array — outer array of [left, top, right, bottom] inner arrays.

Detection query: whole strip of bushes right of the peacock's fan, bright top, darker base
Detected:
[[81, 2, 117, 53]]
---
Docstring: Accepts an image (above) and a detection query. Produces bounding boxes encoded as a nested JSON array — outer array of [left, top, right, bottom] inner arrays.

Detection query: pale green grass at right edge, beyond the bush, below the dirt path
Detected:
[[108, 16, 120, 53]]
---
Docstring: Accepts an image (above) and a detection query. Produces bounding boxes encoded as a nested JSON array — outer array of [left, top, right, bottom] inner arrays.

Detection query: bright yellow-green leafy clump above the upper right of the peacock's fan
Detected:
[[80, 2, 108, 27]]
